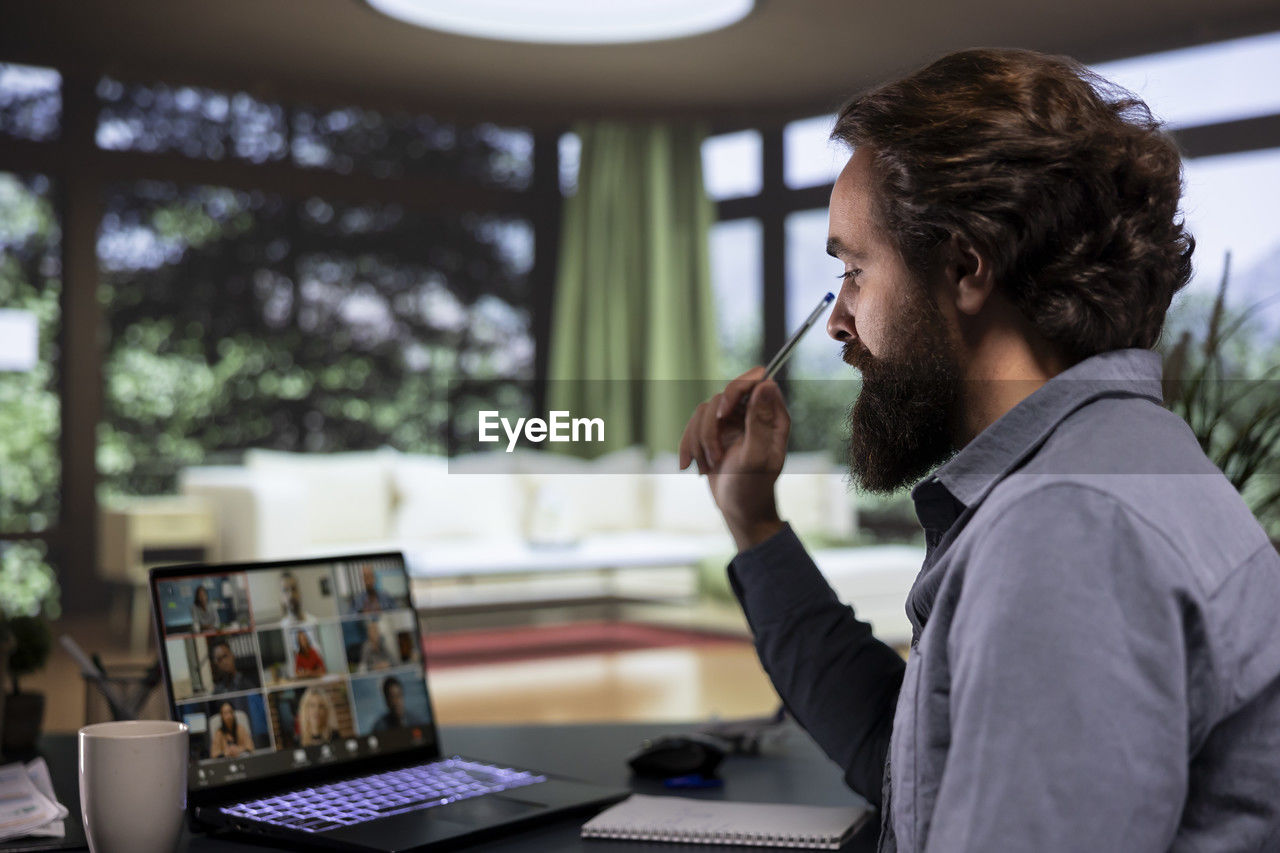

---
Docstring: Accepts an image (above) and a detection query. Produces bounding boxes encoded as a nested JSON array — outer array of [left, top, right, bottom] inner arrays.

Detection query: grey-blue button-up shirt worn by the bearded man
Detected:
[[730, 350, 1280, 853]]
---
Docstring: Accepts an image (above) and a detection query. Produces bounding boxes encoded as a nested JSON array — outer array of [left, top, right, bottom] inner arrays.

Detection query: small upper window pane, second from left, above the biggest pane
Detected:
[[96, 77, 287, 163]]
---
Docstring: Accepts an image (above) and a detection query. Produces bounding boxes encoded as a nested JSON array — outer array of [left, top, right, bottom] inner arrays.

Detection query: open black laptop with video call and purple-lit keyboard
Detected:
[[150, 553, 630, 853]]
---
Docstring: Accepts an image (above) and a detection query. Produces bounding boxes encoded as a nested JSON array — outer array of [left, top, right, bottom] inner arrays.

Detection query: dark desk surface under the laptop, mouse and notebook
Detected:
[[20, 724, 879, 853]]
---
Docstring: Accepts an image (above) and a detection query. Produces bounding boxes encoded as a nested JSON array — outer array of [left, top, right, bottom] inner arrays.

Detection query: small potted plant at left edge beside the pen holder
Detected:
[[0, 542, 60, 756]]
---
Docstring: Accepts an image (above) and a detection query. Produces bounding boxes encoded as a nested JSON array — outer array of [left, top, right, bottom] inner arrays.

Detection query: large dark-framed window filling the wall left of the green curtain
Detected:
[[0, 64, 545, 589]]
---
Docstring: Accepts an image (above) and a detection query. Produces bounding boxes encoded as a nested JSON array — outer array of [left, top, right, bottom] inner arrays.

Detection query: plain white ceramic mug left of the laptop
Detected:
[[79, 720, 188, 853]]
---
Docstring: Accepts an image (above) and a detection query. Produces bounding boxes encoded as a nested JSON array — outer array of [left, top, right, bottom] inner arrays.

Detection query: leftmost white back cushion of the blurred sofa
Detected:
[[244, 448, 397, 544]]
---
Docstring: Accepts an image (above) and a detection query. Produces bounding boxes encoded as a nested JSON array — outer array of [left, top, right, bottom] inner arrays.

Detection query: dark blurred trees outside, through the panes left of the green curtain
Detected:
[[90, 81, 534, 497]]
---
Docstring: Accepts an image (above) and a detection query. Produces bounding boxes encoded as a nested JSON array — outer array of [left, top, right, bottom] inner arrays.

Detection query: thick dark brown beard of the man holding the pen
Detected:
[[842, 283, 960, 494]]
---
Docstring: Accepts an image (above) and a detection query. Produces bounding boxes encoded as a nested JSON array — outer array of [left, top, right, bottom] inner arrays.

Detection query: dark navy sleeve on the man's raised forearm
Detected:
[[728, 517, 905, 807]]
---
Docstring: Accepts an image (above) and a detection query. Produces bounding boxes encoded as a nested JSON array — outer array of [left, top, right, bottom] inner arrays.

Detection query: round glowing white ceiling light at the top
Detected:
[[366, 0, 755, 45]]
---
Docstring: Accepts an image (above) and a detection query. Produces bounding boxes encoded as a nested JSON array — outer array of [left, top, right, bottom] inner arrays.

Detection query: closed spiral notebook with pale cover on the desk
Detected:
[[582, 794, 872, 850]]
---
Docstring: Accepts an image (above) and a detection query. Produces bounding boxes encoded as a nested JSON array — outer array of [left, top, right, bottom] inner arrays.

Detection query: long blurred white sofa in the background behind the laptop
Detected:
[[179, 440, 919, 642]]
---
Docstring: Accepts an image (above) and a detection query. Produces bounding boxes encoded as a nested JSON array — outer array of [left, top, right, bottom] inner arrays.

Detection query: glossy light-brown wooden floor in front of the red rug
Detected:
[[23, 611, 778, 731]]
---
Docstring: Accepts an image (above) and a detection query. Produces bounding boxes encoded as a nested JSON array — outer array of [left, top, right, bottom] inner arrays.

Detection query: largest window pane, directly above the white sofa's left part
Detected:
[[99, 182, 534, 496]]
